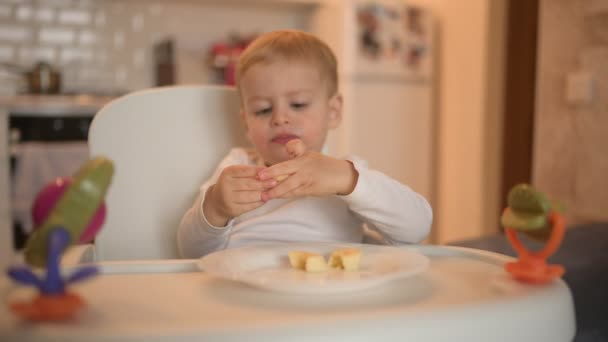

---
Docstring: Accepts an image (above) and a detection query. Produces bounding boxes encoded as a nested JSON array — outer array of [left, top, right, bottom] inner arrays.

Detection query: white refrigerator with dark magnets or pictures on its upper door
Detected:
[[312, 0, 436, 202]]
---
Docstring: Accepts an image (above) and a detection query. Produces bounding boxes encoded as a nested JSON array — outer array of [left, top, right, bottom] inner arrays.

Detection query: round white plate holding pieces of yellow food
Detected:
[[198, 243, 429, 294]]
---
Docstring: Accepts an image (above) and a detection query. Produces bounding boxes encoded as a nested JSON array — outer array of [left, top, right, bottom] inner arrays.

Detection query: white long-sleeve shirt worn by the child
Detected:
[[177, 148, 433, 258]]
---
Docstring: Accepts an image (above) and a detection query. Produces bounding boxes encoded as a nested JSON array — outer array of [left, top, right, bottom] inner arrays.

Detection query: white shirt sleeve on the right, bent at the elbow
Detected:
[[342, 158, 433, 244]]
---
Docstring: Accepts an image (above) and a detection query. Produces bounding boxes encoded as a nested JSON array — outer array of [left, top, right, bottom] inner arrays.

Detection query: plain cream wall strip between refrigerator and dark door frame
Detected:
[[412, 0, 506, 243]]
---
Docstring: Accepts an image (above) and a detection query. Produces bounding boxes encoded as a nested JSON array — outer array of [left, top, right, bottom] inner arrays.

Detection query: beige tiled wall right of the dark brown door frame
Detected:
[[533, 0, 608, 223]]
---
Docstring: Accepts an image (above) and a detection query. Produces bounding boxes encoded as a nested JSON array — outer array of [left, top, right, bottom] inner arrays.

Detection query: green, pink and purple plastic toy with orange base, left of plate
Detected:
[[8, 157, 114, 321]]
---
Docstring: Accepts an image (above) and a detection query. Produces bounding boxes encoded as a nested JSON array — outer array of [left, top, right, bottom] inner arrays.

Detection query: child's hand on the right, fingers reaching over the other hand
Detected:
[[258, 151, 359, 201]]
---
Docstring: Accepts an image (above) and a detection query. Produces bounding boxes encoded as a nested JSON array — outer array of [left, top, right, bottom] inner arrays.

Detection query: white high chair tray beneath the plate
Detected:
[[0, 246, 575, 341]]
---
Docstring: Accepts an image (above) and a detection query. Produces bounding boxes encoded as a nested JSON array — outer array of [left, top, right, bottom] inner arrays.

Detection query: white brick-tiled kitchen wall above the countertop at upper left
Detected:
[[0, 0, 309, 93]]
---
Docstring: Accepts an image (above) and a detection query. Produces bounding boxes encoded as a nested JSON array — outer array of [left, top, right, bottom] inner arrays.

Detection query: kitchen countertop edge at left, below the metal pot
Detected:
[[0, 95, 115, 116]]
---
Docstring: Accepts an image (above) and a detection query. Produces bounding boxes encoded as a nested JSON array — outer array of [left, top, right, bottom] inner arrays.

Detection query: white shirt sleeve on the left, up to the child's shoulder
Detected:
[[177, 148, 248, 258]]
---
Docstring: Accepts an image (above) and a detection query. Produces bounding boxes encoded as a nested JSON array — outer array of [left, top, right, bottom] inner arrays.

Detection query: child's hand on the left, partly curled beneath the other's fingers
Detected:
[[203, 165, 278, 227]]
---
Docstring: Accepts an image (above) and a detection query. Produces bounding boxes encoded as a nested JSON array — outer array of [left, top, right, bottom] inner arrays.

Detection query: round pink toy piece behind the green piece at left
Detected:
[[32, 177, 106, 243]]
